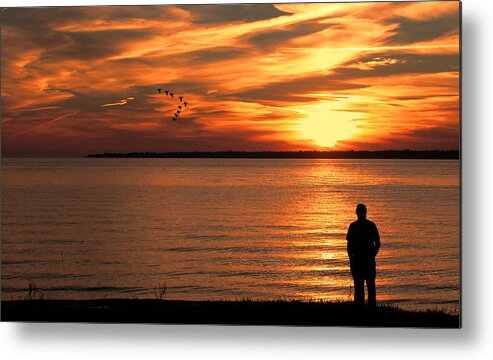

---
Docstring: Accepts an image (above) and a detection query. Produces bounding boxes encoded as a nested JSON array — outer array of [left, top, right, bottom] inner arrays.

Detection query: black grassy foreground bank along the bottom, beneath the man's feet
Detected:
[[1, 299, 460, 328]]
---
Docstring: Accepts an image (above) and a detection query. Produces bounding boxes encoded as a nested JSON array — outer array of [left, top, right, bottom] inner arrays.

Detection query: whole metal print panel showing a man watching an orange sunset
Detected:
[[0, 1, 460, 327]]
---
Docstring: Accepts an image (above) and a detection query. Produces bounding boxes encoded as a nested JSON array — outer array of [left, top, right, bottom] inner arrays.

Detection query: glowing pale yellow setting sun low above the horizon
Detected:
[[296, 104, 360, 148]]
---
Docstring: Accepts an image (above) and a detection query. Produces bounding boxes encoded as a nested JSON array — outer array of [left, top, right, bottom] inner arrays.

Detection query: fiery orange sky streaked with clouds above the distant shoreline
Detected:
[[0, 1, 460, 156]]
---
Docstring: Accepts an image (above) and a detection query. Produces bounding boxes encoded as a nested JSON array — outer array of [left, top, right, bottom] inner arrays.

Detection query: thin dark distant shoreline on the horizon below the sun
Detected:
[[86, 150, 460, 160]]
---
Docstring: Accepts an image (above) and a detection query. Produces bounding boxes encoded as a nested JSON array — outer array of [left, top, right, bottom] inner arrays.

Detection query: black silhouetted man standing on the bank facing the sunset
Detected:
[[346, 204, 380, 308]]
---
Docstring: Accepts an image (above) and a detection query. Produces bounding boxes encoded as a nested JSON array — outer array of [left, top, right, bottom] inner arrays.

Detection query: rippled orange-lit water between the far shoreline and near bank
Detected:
[[1, 158, 460, 311]]
